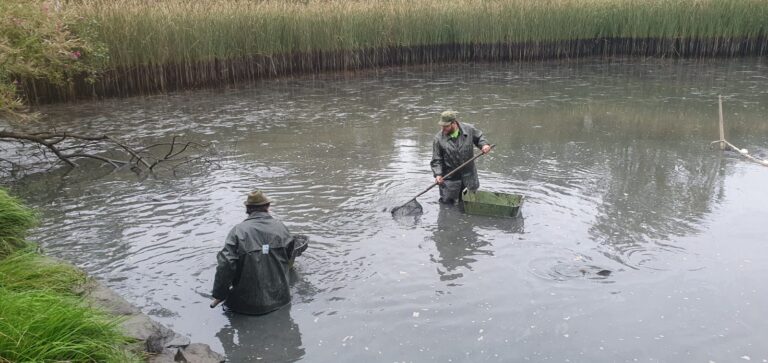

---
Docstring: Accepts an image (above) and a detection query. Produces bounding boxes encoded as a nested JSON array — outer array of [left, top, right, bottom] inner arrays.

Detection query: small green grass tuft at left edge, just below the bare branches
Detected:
[[0, 189, 37, 258]]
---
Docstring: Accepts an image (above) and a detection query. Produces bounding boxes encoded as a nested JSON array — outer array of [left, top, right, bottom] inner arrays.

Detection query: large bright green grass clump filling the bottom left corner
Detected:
[[0, 287, 139, 363]]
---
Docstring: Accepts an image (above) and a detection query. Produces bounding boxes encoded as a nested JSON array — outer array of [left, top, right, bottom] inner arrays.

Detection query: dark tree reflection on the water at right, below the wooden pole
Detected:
[[589, 142, 724, 270]]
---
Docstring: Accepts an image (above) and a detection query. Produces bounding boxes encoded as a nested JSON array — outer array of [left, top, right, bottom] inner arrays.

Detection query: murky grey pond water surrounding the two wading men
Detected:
[[6, 59, 768, 362]]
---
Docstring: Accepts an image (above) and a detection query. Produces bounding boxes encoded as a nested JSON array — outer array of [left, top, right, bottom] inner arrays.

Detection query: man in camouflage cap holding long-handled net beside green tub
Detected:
[[430, 111, 491, 204]]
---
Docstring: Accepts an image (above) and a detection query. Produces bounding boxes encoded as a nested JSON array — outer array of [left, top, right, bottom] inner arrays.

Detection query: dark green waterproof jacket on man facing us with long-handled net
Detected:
[[430, 122, 488, 190]]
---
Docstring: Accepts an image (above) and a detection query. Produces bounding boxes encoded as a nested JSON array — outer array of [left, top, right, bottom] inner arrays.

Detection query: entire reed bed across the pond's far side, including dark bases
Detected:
[[27, 0, 768, 101]]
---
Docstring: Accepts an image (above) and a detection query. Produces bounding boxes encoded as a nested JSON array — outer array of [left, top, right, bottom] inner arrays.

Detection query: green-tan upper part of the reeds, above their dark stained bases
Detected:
[[76, 0, 768, 67]]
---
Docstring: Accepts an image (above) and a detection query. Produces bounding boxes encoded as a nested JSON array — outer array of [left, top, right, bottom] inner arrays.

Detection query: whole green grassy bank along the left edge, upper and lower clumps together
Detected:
[[0, 189, 141, 363]]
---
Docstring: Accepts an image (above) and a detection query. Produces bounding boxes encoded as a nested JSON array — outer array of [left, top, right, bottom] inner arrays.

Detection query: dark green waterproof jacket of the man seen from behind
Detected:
[[213, 212, 295, 314]]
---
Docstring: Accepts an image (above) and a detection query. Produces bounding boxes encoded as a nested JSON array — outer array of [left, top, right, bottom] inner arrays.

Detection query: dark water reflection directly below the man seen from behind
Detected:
[[216, 305, 305, 362]]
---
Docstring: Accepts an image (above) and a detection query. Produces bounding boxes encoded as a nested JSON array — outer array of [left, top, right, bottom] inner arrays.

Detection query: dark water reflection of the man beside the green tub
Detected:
[[430, 203, 524, 281]]
